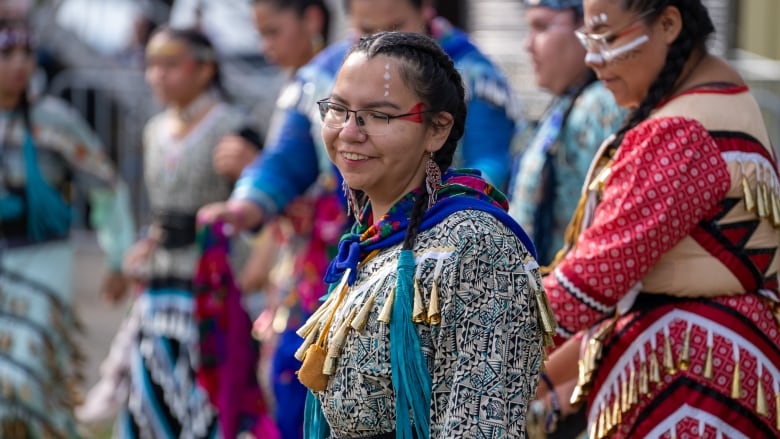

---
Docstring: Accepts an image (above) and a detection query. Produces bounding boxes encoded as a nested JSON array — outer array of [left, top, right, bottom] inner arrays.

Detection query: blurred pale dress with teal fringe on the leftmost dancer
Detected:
[[0, 97, 134, 438]]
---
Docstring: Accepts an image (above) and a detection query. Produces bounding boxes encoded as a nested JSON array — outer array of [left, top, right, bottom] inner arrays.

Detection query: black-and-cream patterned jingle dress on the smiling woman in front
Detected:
[[299, 171, 552, 439]]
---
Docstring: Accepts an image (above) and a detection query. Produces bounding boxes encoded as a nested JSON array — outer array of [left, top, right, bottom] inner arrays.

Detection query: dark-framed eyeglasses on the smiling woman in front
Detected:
[[317, 100, 434, 136]]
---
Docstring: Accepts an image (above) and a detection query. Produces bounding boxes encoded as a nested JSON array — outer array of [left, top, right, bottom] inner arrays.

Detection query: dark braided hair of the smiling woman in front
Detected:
[[349, 32, 466, 249]]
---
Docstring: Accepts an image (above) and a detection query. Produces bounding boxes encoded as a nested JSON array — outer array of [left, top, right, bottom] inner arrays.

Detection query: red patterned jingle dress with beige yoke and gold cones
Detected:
[[544, 84, 780, 438]]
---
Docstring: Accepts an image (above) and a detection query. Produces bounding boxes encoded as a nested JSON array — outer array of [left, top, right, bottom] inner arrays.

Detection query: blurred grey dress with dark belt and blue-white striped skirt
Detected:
[[115, 103, 260, 438]]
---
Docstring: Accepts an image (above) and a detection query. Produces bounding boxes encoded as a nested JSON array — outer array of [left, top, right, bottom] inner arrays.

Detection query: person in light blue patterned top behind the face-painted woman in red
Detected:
[[507, 0, 625, 265]]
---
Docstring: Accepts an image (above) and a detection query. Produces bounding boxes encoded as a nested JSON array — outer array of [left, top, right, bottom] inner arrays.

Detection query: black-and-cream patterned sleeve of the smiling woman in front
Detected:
[[430, 211, 542, 438]]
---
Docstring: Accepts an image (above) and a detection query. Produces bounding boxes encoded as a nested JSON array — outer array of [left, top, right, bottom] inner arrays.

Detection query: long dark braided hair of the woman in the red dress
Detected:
[[610, 0, 715, 153]]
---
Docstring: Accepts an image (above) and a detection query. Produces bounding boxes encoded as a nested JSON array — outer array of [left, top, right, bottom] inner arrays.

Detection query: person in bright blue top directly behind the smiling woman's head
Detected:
[[201, 0, 523, 234]]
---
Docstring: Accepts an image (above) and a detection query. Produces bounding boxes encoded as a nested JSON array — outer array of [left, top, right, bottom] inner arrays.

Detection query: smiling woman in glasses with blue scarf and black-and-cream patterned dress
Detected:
[[298, 32, 553, 438]]
